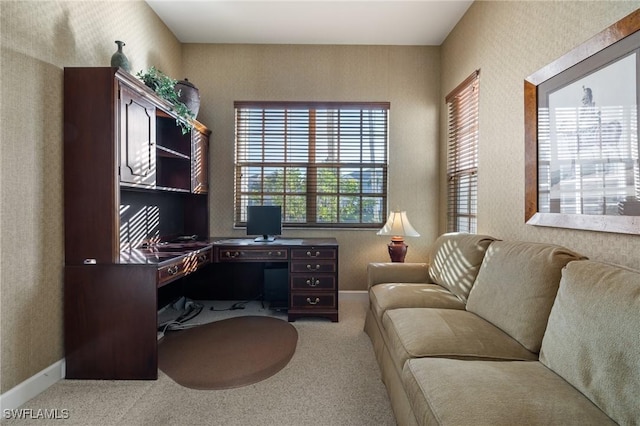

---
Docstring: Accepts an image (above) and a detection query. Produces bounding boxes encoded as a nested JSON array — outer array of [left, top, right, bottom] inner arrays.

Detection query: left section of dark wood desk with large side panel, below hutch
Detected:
[[64, 241, 212, 380]]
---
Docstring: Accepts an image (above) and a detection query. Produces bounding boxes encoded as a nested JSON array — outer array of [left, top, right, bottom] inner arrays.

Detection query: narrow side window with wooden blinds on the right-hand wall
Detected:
[[445, 70, 480, 233]]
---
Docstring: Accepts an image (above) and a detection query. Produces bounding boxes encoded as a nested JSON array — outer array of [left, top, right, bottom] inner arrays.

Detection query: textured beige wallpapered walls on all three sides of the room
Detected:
[[5, 1, 640, 392]]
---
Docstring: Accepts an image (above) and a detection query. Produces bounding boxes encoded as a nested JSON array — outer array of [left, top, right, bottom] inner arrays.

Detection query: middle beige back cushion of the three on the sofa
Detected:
[[467, 241, 584, 353]]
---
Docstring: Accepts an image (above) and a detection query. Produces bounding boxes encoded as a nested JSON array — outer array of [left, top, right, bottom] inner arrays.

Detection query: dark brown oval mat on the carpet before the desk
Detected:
[[158, 316, 298, 389]]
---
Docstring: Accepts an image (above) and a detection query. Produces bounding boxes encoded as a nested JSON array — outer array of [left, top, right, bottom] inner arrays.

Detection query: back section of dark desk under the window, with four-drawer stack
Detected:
[[213, 238, 338, 322]]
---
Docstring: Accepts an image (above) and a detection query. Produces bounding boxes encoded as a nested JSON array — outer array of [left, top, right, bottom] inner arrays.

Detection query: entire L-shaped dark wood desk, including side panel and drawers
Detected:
[[64, 238, 338, 380]]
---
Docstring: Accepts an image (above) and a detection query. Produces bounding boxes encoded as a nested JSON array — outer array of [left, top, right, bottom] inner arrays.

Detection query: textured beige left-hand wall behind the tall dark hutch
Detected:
[[0, 1, 182, 392]]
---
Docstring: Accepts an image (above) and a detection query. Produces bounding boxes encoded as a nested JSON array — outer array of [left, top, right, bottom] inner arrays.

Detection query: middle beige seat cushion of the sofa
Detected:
[[382, 308, 538, 374]]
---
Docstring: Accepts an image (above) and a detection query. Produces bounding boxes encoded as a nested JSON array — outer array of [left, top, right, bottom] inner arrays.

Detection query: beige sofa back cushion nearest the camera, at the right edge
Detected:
[[540, 261, 640, 425]]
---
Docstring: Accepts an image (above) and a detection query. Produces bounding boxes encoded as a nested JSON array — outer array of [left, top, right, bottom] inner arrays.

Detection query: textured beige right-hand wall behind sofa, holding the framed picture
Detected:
[[440, 1, 640, 268]]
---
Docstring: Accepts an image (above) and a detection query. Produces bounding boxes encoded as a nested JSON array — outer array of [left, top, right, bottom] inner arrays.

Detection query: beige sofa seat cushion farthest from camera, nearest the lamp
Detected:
[[369, 283, 464, 320]]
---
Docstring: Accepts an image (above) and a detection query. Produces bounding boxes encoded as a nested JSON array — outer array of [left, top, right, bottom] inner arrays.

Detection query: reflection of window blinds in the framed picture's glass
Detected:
[[538, 105, 640, 216]]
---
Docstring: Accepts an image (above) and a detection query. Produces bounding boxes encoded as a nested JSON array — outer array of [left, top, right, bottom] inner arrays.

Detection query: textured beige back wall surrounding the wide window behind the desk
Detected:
[[184, 44, 440, 290]]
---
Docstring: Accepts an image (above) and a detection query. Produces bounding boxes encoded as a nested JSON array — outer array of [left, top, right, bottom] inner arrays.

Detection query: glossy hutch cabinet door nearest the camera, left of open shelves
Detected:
[[120, 85, 156, 187]]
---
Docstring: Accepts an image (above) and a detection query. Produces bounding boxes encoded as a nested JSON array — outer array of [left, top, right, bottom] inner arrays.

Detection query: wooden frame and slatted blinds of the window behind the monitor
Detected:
[[234, 101, 390, 229]]
